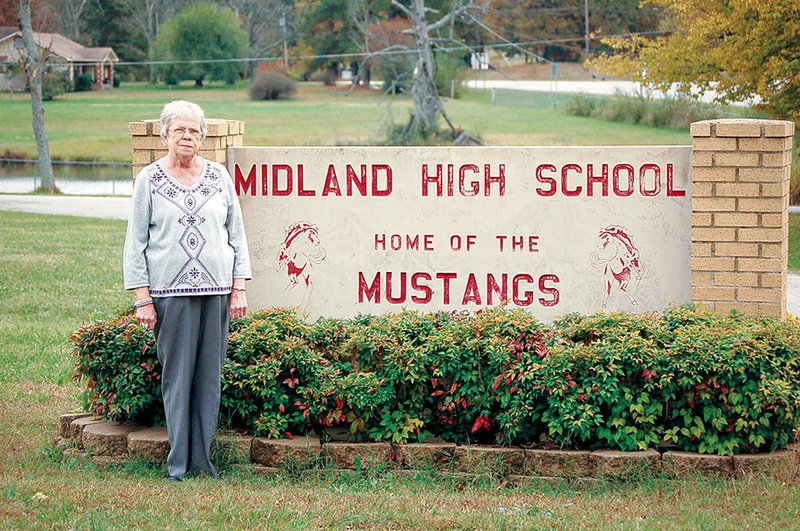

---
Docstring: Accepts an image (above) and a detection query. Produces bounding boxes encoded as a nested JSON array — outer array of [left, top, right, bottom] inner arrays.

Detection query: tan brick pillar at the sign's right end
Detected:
[[691, 120, 794, 318]]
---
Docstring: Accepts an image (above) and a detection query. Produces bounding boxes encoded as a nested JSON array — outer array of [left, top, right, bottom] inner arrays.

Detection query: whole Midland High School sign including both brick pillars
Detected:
[[129, 120, 794, 320]]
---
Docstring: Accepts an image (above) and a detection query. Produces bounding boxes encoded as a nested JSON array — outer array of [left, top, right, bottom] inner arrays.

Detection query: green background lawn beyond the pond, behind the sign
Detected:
[[0, 83, 691, 161]]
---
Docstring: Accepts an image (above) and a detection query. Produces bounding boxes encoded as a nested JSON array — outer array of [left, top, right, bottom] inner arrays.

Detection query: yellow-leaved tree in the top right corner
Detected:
[[591, 0, 800, 121]]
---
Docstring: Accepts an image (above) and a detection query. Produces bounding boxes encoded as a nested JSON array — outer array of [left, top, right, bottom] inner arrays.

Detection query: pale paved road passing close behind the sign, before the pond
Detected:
[[0, 194, 800, 315]]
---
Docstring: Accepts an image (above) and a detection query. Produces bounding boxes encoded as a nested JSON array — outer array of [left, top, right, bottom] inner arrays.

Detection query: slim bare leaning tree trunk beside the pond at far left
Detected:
[[19, 0, 58, 194]]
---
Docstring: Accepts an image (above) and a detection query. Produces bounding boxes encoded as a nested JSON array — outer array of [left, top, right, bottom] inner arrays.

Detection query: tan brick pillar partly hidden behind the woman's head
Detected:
[[128, 119, 244, 178]]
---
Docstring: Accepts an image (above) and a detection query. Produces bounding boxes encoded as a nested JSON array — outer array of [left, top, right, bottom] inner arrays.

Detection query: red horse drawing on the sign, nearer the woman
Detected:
[[275, 221, 327, 292]]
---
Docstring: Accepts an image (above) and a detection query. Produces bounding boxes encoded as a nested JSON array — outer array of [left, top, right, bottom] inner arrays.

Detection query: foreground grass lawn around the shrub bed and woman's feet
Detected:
[[0, 212, 800, 529]]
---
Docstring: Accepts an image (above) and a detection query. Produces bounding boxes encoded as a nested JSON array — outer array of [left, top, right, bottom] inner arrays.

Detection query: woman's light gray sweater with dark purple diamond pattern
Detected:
[[124, 159, 252, 297]]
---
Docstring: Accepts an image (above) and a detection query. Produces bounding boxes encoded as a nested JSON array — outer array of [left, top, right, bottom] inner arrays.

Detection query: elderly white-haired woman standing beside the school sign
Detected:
[[124, 101, 251, 481]]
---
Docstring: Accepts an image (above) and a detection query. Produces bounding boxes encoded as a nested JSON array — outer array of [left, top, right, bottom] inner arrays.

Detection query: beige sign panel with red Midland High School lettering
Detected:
[[228, 146, 691, 320]]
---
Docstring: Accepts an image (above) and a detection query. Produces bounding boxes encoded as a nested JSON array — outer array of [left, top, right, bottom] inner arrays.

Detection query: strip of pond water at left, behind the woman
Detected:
[[0, 159, 133, 195]]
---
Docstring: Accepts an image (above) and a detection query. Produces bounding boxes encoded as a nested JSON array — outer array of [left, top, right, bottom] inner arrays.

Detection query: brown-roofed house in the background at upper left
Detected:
[[0, 26, 119, 91]]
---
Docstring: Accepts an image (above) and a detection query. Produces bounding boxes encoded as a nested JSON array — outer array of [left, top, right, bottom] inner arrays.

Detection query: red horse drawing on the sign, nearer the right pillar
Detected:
[[592, 225, 642, 308]]
